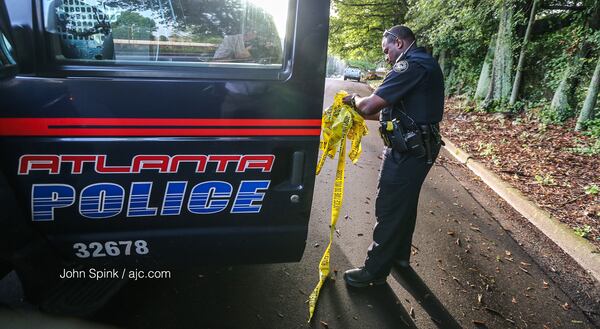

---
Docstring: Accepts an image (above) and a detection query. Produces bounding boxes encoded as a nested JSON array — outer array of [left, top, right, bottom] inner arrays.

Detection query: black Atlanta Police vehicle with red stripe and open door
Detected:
[[0, 0, 329, 308]]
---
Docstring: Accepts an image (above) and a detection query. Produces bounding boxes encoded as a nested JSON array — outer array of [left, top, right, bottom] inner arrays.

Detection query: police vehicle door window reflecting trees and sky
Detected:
[[44, 0, 288, 69]]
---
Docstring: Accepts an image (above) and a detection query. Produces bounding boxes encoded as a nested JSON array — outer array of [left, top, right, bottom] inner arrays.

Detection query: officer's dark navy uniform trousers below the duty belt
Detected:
[[365, 145, 440, 276]]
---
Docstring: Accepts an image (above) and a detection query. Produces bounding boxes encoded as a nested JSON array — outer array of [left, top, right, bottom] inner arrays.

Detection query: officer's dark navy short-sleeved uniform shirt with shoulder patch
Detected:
[[375, 47, 444, 124]]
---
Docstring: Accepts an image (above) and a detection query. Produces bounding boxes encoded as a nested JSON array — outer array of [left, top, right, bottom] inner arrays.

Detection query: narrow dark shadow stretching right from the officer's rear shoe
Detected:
[[392, 266, 462, 329]]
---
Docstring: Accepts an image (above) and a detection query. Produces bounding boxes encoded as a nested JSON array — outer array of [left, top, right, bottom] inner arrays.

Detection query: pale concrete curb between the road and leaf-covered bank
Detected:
[[442, 138, 600, 282]]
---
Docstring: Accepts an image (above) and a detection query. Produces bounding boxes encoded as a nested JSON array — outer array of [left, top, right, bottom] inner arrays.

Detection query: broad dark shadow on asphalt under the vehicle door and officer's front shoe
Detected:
[[88, 244, 417, 329]]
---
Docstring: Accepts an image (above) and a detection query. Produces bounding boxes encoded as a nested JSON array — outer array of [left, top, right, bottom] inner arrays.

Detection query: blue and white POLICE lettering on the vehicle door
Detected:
[[31, 180, 270, 222]]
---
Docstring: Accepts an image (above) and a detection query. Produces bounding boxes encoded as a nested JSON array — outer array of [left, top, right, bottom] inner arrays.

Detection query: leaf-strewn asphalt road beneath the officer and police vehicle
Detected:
[[0, 80, 593, 329]]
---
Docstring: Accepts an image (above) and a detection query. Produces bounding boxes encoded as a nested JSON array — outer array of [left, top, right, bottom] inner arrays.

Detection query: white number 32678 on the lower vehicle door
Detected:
[[73, 240, 150, 258]]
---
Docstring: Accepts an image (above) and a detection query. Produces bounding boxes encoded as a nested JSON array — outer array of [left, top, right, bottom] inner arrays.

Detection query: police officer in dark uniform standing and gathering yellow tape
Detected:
[[344, 25, 444, 287]]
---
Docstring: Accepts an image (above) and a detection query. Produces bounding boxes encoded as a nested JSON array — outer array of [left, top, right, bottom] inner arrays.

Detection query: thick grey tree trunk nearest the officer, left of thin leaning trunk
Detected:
[[483, 0, 513, 108]]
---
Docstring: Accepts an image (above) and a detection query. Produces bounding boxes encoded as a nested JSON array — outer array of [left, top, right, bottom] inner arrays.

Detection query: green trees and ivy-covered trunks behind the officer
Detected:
[[329, 0, 600, 128]]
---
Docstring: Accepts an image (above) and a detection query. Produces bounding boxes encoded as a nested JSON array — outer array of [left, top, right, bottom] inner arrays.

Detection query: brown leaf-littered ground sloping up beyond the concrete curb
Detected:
[[442, 100, 600, 247]]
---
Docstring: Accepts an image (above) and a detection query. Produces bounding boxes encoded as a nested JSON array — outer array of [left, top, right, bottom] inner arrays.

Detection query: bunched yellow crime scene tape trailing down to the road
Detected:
[[308, 90, 369, 322]]
